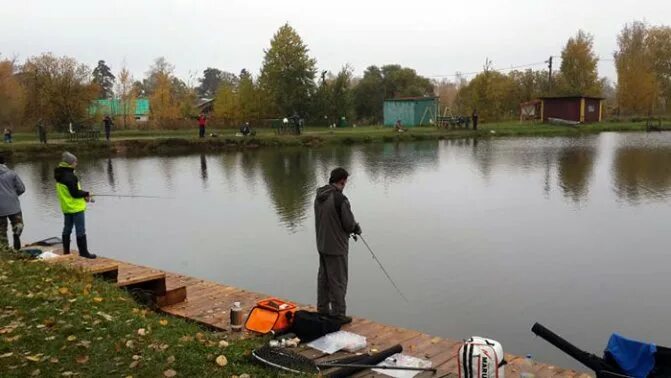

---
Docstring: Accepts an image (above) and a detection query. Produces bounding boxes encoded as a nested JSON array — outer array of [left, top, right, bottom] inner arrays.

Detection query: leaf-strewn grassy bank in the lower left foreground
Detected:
[[0, 250, 284, 377]]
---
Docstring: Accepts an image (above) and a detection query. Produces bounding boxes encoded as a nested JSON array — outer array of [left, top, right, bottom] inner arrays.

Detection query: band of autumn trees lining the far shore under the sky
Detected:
[[0, 22, 671, 130]]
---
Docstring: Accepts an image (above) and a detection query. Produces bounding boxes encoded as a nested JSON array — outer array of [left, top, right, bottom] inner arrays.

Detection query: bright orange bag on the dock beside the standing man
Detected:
[[245, 298, 296, 334]]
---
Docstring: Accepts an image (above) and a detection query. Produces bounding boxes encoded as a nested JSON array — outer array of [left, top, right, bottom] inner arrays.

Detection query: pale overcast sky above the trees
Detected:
[[0, 0, 671, 84]]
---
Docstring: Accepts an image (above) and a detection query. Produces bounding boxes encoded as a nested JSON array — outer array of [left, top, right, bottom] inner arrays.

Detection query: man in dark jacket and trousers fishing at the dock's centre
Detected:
[[315, 168, 361, 324]]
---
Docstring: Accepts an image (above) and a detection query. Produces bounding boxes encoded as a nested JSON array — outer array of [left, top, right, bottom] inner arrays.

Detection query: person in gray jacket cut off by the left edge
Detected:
[[0, 155, 26, 249]]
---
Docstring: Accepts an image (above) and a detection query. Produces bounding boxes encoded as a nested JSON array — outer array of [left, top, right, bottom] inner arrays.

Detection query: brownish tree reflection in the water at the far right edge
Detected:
[[613, 146, 671, 203]]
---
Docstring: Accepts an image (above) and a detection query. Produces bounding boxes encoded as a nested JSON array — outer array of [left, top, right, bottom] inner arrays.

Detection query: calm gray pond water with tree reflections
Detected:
[[14, 133, 671, 367]]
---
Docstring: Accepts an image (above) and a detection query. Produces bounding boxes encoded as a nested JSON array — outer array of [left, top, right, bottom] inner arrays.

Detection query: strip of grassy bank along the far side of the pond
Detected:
[[0, 122, 671, 159]]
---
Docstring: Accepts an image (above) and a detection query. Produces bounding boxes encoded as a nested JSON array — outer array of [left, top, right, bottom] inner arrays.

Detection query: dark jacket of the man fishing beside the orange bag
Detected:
[[315, 185, 359, 256]]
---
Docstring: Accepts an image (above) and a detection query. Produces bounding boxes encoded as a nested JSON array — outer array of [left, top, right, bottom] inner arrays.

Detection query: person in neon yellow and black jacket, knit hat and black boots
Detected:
[[54, 151, 96, 259]]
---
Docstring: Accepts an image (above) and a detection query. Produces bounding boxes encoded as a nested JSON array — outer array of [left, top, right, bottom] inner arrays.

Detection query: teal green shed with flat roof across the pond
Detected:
[[384, 97, 438, 127]]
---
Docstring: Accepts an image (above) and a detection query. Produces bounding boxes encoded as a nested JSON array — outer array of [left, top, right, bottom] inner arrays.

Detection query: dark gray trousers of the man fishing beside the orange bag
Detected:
[[317, 253, 347, 316]]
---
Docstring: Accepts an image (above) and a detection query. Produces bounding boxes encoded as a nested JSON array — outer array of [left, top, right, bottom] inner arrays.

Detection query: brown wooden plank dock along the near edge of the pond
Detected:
[[36, 246, 589, 378]]
